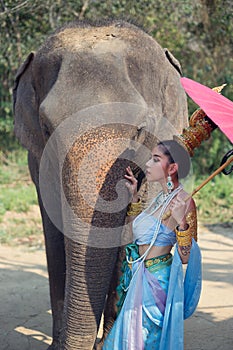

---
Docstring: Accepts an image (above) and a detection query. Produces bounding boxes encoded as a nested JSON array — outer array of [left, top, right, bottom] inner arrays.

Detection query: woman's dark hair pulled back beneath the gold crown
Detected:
[[157, 140, 191, 179]]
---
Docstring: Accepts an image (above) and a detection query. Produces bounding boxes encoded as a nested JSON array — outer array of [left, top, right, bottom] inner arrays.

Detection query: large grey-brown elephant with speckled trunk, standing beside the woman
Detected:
[[13, 20, 188, 350]]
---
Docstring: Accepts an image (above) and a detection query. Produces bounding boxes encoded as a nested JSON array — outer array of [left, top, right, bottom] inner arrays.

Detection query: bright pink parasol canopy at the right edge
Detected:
[[181, 77, 233, 143]]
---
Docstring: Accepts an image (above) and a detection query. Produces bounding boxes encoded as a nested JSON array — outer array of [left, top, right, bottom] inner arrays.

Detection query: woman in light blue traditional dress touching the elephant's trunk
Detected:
[[103, 140, 201, 350]]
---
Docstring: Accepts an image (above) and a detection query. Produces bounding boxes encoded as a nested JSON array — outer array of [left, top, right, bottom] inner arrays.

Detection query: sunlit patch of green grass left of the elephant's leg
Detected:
[[0, 149, 43, 246]]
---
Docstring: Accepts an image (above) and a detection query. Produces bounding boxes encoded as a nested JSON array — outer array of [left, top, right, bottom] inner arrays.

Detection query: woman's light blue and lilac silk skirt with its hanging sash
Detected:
[[103, 240, 201, 350]]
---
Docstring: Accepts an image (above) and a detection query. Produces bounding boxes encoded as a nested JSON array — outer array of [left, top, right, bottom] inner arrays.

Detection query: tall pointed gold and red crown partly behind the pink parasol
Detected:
[[174, 84, 226, 157]]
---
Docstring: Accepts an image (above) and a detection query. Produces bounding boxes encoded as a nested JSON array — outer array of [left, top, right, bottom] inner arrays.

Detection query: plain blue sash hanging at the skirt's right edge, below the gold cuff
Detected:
[[159, 239, 202, 350]]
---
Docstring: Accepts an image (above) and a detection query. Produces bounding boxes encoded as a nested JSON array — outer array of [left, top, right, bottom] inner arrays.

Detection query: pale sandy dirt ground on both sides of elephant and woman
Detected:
[[0, 225, 233, 350]]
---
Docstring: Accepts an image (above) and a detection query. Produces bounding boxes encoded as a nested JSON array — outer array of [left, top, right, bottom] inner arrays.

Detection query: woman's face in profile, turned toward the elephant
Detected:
[[146, 146, 170, 183]]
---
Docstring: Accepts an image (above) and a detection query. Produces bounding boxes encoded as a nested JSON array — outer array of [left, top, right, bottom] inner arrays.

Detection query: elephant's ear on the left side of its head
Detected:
[[13, 52, 44, 157]]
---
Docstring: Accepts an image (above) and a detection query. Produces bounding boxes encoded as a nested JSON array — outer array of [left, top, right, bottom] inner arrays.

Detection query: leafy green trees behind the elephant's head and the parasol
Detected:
[[0, 0, 233, 173]]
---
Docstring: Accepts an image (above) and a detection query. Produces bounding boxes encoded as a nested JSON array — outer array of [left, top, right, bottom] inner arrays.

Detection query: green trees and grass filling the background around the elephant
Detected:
[[0, 0, 233, 245]]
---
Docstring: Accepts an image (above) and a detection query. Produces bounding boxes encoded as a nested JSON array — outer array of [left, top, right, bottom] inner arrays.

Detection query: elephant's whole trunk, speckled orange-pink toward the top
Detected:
[[57, 128, 135, 350]]
